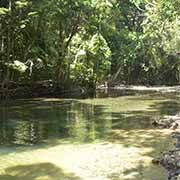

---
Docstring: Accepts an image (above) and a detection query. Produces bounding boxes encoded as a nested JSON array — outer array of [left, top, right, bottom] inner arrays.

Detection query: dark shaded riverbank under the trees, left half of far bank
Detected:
[[0, 80, 89, 100]]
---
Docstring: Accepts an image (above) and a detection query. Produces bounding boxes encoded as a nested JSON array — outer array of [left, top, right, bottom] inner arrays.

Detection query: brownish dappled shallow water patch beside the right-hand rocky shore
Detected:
[[108, 129, 172, 157]]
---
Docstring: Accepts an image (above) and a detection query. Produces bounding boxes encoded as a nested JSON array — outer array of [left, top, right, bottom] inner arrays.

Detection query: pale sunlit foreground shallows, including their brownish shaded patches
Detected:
[[0, 130, 174, 180]]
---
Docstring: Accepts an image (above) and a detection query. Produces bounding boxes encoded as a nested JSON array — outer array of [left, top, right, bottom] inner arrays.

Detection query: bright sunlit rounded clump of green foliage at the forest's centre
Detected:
[[70, 34, 111, 85]]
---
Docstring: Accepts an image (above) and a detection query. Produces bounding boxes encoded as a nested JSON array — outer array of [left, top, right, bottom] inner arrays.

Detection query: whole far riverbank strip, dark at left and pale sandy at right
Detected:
[[0, 84, 180, 100]]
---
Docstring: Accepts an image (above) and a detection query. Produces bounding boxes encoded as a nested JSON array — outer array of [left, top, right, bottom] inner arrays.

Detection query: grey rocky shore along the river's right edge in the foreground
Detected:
[[152, 114, 180, 180]]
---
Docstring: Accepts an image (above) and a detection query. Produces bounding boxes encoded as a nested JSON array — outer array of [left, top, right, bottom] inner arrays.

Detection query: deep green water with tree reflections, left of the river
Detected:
[[0, 101, 111, 145]]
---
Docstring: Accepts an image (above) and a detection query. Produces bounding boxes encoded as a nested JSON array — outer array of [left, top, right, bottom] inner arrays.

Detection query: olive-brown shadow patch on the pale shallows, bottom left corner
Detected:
[[0, 163, 80, 180]]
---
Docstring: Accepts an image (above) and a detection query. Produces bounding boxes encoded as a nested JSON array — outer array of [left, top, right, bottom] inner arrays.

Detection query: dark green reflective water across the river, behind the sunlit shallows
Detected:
[[0, 96, 180, 145]]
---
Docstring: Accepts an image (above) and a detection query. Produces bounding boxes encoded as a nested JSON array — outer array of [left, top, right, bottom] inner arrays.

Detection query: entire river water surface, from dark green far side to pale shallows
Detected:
[[0, 95, 180, 180]]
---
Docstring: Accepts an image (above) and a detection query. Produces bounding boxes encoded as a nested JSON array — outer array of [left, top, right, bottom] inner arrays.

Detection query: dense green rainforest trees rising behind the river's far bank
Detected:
[[0, 0, 180, 96]]
